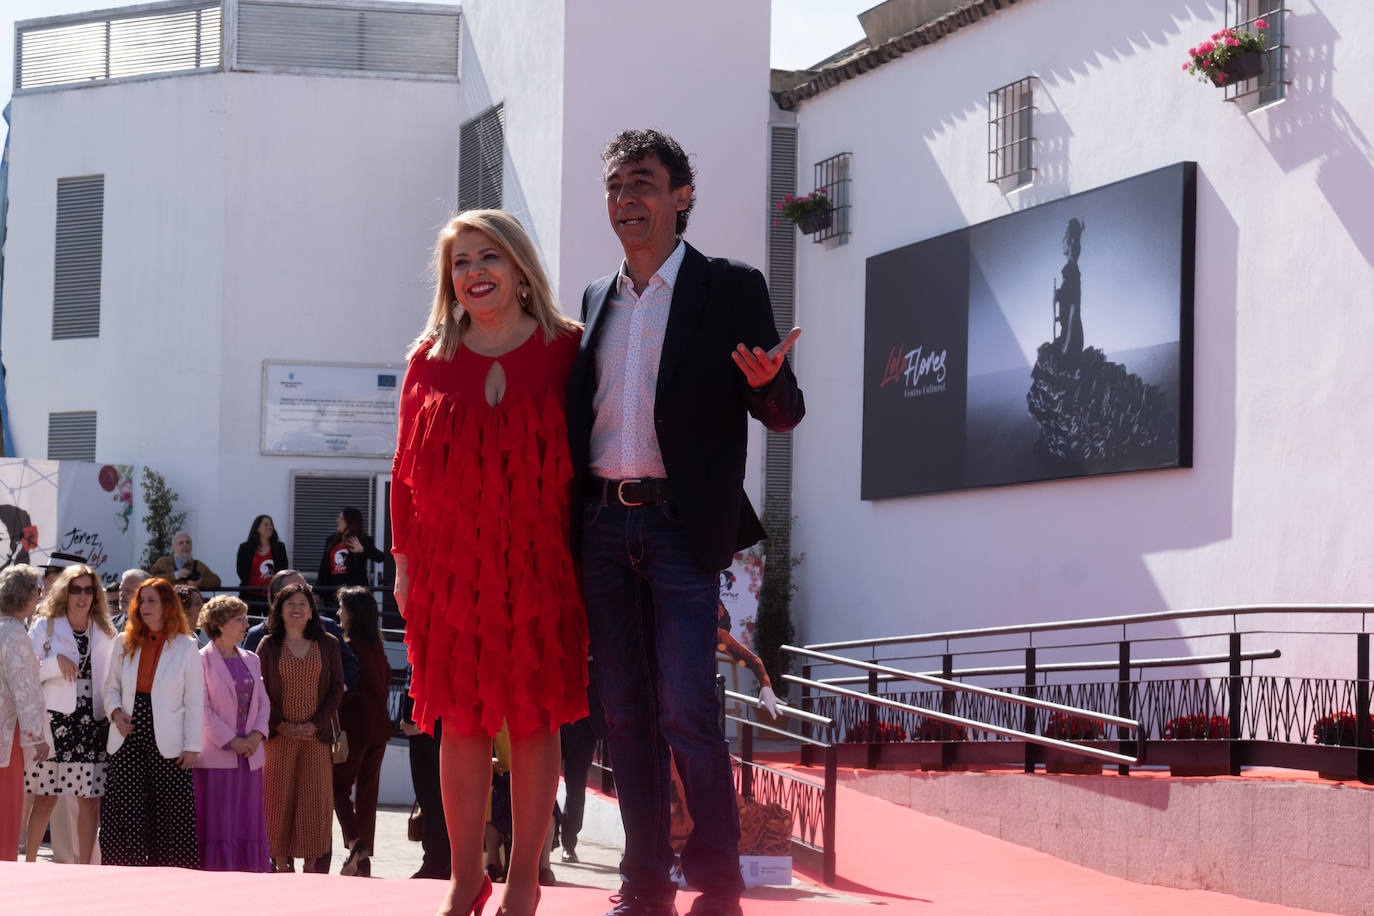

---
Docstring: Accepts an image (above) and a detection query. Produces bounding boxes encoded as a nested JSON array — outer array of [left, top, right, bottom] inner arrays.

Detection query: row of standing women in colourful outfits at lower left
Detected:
[[0, 563, 406, 875]]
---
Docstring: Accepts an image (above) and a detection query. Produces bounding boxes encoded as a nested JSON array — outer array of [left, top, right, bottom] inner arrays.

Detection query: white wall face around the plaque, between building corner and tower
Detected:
[[214, 73, 462, 582]]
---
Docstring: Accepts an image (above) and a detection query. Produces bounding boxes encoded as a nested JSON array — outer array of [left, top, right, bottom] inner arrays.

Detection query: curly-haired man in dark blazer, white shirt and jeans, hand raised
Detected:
[[567, 130, 805, 916]]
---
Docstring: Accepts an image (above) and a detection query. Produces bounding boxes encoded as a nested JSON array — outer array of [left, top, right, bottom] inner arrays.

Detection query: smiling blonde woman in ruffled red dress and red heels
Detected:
[[392, 210, 587, 916]]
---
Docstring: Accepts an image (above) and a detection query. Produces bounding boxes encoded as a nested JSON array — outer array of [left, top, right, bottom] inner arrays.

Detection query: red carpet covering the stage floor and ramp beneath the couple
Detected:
[[0, 787, 1330, 916]]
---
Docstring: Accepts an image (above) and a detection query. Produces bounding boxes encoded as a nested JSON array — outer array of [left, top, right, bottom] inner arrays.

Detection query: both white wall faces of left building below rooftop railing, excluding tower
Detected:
[[3, 73, 462, 584]]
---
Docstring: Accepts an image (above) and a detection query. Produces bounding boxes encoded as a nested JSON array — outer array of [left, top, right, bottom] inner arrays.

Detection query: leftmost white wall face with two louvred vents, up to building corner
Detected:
[[3, 77, 230, 560]]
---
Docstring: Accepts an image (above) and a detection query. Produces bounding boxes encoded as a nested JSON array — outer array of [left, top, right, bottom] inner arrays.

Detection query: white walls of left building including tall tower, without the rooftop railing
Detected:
[[3, 0, 768, 584]]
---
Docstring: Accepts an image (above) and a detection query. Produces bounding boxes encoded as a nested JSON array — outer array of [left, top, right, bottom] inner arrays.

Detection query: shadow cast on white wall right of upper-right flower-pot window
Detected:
[[1250, 4, 1374, 265]]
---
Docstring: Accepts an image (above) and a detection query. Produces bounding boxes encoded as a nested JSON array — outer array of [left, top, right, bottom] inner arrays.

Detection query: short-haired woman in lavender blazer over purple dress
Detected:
[[195, 595, 271, 872]]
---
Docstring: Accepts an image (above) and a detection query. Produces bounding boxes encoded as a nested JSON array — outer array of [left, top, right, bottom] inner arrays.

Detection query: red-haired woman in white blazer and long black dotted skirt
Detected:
[[100, 578, 205, 868]]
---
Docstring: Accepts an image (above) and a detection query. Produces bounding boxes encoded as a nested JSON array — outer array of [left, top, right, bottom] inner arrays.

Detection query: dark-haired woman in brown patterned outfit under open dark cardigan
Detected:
[[258, 585, 344, 872]]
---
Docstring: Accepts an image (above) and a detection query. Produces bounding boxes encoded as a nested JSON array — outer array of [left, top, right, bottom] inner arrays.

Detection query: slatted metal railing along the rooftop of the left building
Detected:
[[14, 0, 459, 95]]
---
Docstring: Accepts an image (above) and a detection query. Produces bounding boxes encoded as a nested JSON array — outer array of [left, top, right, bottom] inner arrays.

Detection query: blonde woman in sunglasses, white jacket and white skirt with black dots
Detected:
[[25, 563, 114, 865]]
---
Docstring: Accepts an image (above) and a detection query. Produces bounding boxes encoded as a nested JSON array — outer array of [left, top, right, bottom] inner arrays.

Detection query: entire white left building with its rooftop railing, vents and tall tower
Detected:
[[0, 0, 768, 584]]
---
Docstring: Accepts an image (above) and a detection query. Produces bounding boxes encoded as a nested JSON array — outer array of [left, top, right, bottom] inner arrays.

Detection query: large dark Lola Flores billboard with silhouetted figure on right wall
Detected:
[[860, 162, 1197, 500]]
